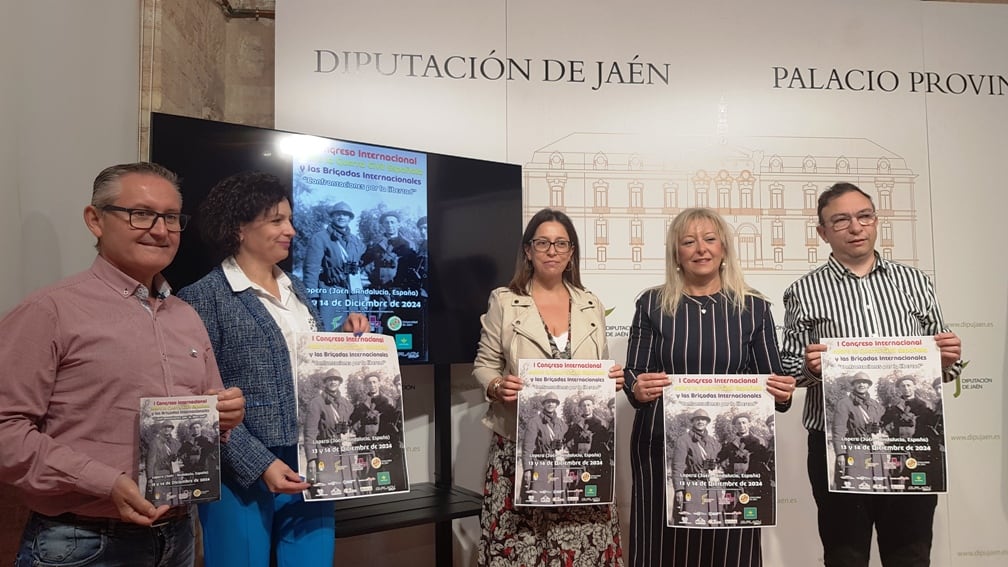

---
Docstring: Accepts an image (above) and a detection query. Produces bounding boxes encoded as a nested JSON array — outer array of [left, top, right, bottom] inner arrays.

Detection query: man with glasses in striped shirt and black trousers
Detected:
[[781, 183, 962, 567]]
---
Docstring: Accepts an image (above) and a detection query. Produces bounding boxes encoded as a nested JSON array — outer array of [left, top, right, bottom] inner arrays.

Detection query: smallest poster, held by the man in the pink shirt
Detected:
[[137, 395, 221, 505]]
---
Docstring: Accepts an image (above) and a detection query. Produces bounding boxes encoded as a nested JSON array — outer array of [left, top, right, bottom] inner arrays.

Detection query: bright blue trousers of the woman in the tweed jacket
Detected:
[[200, 446, 336, 567]]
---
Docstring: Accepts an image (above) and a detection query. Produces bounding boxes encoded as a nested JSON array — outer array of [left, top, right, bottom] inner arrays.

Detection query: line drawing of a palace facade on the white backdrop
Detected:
[[523, 132, 929, 277]]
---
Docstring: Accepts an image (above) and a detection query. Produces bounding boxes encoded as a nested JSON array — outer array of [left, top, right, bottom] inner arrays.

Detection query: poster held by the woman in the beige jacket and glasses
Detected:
[[514, 359, 616, 506]]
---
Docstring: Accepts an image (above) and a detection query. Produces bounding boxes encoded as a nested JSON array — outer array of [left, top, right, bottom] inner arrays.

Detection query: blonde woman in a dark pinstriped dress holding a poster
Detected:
[[624, 209, 794, 567]]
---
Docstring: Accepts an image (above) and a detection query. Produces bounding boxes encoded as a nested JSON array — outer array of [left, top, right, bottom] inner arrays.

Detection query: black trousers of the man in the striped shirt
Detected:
[[807, 430, 937, 567]]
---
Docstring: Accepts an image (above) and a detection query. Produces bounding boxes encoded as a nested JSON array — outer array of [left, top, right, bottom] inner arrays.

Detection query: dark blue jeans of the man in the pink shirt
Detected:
[[14, 513, 196, 567]]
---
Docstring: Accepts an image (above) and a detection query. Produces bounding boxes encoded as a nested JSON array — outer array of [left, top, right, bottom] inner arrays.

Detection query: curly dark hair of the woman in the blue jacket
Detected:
[[200, 172, 291, 259]]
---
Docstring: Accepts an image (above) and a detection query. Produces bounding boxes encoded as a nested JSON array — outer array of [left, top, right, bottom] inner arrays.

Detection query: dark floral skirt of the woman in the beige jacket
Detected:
[[477, 433, 623, 567]]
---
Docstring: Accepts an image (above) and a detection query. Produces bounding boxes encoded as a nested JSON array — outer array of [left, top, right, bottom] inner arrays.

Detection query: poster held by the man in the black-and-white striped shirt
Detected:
[[823, 337, 948, 493]]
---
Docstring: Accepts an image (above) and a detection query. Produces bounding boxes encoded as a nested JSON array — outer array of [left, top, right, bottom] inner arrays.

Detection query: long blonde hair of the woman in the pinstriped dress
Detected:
[[656, 207, 765, 316]]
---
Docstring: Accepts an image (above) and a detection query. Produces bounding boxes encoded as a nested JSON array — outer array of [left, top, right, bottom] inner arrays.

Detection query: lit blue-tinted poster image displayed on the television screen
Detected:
[[291, 141, 429, 361]]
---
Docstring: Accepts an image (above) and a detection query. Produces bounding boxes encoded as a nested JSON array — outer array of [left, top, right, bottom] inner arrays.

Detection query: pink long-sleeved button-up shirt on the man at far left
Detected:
[[0, 256, 223, 518]]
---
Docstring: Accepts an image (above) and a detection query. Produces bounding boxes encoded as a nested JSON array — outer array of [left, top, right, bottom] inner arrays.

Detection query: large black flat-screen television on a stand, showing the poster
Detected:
[[150, 113, 522, 363]]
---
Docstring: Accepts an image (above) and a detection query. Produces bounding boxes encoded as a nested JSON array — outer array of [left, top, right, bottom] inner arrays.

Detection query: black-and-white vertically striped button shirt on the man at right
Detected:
[[780, 253, 962, 431]]
